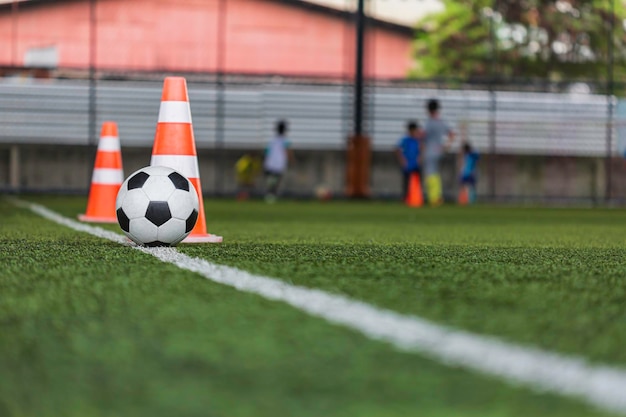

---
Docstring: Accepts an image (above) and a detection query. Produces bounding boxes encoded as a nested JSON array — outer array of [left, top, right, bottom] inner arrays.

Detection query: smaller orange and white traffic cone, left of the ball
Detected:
[[78, 122, 124, 223]]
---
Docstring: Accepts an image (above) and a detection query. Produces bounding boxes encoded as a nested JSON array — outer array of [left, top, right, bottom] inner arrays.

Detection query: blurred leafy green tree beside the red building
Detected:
[[411, 0, 626, 80]]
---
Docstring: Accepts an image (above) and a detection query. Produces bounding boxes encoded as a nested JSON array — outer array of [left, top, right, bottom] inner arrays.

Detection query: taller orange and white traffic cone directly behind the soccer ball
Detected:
[[150, 77, 222, 243]]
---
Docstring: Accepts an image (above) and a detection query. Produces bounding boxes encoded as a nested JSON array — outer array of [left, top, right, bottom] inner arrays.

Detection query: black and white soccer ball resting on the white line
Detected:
[[115, 166, 199, 246]]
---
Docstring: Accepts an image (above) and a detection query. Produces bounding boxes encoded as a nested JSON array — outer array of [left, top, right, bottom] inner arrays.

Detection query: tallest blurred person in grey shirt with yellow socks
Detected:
[[424, 99, 455, 206]]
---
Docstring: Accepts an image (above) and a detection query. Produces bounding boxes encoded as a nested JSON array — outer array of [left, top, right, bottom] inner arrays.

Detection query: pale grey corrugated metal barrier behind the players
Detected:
[[0, 79, 624, 156]]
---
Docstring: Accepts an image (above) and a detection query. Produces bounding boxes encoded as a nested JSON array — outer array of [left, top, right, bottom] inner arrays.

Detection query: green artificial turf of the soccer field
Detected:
[[0, 196, 626, 417]]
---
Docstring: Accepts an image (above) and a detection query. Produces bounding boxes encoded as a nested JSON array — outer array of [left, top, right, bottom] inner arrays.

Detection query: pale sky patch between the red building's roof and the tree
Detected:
[[306, 0, 443, 26]]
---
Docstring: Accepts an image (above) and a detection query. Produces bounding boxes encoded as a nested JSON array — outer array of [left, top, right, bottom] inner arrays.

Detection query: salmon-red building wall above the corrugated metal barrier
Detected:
[[0, 0, 411, 78]]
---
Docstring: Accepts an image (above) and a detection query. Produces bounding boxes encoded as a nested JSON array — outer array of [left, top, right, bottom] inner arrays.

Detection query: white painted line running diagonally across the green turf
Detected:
[[14, 200, 626, 414]]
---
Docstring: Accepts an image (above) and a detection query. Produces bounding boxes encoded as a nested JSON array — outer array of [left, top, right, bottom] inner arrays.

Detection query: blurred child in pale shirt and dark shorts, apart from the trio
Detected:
[[263, 120, 293, 203]]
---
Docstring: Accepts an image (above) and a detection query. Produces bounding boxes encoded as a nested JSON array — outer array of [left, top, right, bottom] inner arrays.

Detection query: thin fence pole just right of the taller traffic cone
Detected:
[[214, 0, 226, 195]]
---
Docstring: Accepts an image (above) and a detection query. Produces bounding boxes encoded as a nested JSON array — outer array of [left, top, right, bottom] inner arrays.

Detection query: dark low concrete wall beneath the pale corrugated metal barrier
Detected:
[[0, 145, 626, 203]]
